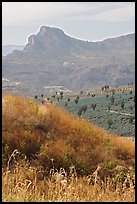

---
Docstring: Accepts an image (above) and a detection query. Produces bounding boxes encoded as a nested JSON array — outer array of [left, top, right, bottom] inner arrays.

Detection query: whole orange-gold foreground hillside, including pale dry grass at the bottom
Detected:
[[2, 94, 135, 202]]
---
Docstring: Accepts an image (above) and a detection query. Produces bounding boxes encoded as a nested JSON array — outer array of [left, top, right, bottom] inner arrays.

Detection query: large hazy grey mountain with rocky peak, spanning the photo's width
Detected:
[[2, 26, 135, 95]]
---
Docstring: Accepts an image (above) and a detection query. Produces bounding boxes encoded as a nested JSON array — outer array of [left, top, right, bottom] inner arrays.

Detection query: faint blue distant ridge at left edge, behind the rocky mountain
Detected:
[[2, 45, 24, 56]]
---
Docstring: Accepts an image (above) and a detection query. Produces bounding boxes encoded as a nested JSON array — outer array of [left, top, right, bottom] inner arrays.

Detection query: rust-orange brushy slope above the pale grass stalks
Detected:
[[2, 95, 135, 174]]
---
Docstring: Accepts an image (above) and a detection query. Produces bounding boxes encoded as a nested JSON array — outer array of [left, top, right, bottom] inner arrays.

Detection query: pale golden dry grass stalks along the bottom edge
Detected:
[[2, 154, 135, 202]]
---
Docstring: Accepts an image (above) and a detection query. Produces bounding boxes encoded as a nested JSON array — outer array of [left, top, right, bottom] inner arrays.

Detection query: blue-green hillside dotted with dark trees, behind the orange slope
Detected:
[[54, 85, 135, 137]]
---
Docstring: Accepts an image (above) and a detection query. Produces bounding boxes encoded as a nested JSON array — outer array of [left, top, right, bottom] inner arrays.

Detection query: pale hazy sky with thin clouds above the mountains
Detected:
[[2, 2, 135, 45]]
